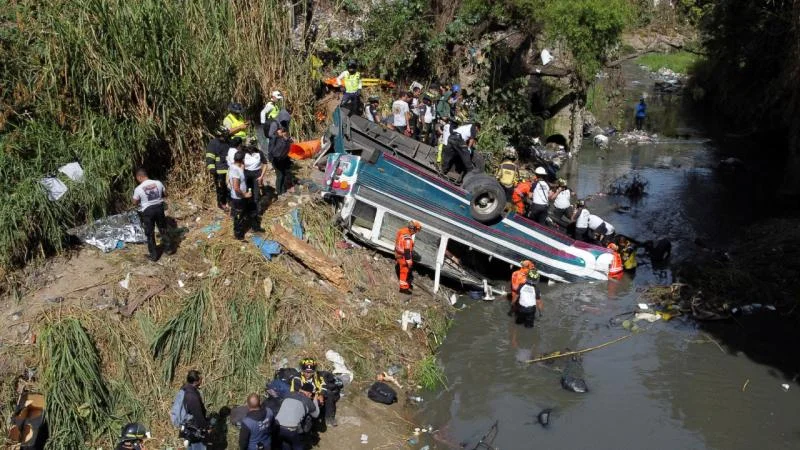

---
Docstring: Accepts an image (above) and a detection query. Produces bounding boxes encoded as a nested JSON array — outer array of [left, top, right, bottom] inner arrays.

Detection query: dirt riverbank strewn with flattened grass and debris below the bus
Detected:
[[0, 160, 451, 449]]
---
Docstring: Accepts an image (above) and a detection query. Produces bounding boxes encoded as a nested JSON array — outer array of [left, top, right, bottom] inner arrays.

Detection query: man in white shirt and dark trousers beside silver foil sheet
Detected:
[[133, 168, 169, 261]]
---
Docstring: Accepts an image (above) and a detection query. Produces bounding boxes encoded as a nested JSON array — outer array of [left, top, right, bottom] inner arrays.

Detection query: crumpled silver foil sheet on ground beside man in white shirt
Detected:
[[67, 211, 147, 253]]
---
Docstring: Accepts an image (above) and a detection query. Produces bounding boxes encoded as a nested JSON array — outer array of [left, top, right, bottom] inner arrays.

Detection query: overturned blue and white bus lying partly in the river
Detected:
[[316, 109, 614, 290]]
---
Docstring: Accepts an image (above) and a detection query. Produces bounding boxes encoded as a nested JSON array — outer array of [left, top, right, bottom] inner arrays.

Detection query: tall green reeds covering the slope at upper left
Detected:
[[0, 0, 311, 266]]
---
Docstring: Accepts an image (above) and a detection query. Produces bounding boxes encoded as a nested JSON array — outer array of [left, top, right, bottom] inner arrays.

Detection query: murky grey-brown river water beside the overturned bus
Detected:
[[417, 66, 800, 450]]
